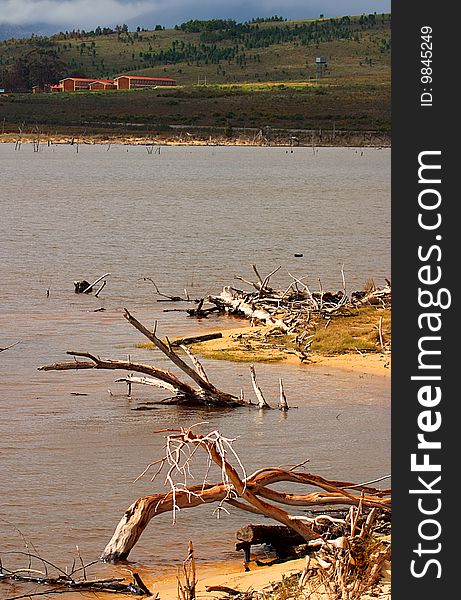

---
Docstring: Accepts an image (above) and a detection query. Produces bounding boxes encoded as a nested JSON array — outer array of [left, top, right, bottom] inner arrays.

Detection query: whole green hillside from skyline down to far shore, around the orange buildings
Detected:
[[0, 15, 390, 139]]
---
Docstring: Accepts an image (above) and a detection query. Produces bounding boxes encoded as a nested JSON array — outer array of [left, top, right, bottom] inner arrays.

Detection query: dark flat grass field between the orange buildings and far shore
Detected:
[[0, 79, 390, 133]]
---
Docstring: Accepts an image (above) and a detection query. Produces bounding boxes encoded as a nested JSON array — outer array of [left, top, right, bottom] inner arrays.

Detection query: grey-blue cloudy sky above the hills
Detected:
[[0, 0, 391, 29]]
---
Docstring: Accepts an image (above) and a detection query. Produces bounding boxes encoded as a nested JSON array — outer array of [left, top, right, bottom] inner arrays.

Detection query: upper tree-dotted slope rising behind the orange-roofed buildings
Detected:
[[0, 15, 390, 91]]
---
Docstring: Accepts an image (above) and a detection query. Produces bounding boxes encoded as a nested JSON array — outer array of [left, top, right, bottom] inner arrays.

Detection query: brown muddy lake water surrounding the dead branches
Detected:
[[0, 144, 390, 598]]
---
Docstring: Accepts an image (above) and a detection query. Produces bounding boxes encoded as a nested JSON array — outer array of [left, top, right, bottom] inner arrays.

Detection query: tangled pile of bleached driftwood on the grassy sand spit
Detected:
[[143, 265, 392, 361]]
